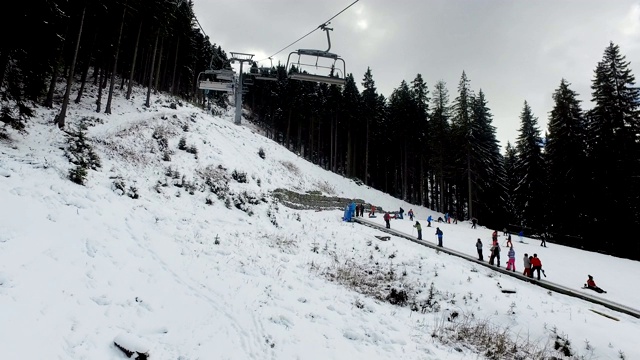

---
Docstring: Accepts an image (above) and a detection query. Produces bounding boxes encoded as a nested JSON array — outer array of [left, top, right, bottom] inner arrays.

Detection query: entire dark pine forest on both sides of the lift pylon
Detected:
[[0, 0, 640, 259]]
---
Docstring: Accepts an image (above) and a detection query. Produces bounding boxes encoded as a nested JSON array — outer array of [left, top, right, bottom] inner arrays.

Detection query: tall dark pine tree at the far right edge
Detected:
[[587, 43, 640, 256]]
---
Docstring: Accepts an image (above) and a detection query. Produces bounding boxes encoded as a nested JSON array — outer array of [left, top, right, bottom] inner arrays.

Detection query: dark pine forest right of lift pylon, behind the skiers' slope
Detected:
[[245, 42, 640, 259]]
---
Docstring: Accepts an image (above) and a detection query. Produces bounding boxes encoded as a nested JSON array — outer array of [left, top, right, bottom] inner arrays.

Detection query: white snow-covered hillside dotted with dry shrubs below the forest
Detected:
[[0, 84, 640, 360]]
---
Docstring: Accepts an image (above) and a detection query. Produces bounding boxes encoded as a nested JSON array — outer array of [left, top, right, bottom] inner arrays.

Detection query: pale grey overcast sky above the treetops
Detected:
[[194, 0, 640, 147]]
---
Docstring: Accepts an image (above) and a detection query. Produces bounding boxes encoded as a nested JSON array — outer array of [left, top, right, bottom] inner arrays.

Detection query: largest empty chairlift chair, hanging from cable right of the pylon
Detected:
[[287, 24, 346, 85]]
